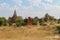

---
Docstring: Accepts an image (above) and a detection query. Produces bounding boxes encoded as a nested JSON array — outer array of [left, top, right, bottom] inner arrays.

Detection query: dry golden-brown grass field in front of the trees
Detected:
[[0, 26, 59, 40]]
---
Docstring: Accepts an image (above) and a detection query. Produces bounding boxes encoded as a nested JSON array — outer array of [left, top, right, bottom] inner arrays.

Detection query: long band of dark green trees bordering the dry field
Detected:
[[0, 13, 60, 26]]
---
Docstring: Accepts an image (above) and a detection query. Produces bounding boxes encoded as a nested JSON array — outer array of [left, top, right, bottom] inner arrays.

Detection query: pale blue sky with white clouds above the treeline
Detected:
[[0, 0, 60, 18]]
